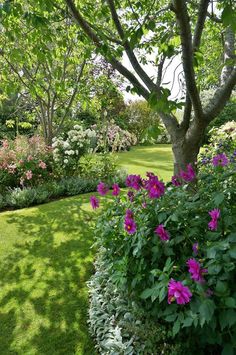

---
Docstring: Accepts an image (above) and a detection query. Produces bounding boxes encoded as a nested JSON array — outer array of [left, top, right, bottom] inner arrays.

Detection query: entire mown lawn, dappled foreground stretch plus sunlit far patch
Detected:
[[0, 147, 171, 355]]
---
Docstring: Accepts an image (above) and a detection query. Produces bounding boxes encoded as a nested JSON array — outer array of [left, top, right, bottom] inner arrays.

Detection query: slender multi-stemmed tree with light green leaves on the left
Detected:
[[0, 3, 90, 145]]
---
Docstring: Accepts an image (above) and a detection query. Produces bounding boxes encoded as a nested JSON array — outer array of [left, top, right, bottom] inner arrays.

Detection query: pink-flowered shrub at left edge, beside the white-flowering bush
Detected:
[[0, 136, 53, 190]]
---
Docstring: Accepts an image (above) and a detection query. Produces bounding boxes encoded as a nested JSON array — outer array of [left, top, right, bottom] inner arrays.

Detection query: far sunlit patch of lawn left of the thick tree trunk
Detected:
[[117, 144, 173, 181]]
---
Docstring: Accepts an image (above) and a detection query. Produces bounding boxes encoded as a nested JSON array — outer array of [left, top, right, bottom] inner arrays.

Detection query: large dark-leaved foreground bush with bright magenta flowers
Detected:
[[91, 161, 236, 354]]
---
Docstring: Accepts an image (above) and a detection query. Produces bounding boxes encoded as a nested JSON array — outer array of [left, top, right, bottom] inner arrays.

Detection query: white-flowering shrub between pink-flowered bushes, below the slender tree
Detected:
[[52, 125, 96, 175]]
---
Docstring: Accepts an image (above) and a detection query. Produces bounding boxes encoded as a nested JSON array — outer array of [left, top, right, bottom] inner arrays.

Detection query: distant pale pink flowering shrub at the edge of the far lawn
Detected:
[[92, 124, 137, 152]]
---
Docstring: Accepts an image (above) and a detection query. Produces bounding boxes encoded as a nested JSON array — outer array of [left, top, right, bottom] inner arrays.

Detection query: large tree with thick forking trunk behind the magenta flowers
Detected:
[[62, 0, 236, 173]]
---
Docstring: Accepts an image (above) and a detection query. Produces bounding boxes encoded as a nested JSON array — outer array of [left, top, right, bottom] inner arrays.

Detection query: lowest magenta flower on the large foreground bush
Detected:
[[168, 279, 192, 304]]
